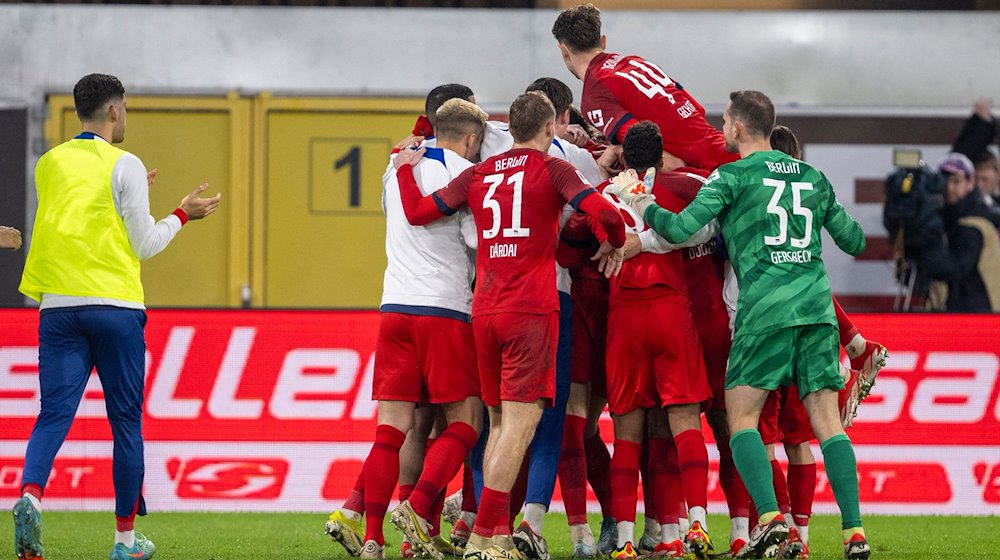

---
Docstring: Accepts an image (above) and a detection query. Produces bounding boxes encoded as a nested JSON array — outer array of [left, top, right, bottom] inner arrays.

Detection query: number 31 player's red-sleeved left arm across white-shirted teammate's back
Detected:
[[392, 148, 473, 226]]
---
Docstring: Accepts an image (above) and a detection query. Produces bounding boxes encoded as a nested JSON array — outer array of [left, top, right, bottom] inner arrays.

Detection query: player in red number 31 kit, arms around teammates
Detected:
[[394, 92, 625, 559]]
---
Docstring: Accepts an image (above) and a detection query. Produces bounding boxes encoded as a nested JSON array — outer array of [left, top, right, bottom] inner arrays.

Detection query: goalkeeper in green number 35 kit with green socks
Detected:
[[614, 91, 871, 559]]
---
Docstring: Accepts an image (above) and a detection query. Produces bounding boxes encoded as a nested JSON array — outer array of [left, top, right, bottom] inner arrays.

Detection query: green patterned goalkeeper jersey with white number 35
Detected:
[[644, 150, 865, 333]]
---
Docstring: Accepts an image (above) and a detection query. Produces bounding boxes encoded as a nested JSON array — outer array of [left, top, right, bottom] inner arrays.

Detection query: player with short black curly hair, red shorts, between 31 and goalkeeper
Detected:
[[605, 122, 714, 559]]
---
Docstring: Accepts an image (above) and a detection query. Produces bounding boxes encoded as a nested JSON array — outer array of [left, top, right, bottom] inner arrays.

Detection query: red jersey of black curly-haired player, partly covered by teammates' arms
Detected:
[[598, 177, 687, 307]]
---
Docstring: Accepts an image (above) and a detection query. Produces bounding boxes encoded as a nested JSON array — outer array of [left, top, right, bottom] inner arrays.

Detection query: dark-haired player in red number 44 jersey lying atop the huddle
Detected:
[[552, 4, 739, 171]]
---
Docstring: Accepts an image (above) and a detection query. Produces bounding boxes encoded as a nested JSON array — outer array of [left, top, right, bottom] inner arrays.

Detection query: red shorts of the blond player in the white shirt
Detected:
[[372, 313, 479, 404]]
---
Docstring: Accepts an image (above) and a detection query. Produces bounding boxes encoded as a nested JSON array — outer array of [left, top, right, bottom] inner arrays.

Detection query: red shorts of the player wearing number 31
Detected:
[[472, 311, 559, 406]]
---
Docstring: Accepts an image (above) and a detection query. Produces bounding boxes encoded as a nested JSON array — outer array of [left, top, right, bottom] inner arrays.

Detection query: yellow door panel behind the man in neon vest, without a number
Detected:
[[45, 93, 251, 307]]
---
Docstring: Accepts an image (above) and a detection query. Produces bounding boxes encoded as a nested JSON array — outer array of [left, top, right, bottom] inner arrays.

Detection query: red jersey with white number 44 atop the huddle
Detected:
[[580, 53, 739, 170]]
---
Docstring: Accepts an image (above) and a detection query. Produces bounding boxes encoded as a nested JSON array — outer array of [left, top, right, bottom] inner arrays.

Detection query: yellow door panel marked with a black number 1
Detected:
[[252, 94, 423, 308]]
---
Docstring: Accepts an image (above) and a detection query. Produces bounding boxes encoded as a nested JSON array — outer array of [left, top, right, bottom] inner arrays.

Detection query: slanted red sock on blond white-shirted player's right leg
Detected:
[[409, 422, 479, 520]]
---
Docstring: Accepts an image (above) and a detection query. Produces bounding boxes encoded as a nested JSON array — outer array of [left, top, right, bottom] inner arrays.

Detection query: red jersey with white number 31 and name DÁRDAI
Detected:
[[435, 148, 595, 316]]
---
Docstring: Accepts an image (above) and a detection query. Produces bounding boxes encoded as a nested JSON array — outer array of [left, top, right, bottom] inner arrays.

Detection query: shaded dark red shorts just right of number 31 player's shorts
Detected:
[[570, 277, 608, 397]]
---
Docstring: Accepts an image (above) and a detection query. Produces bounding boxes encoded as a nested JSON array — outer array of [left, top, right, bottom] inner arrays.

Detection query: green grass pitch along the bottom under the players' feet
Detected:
[[0, 511, 1000, 560]]
